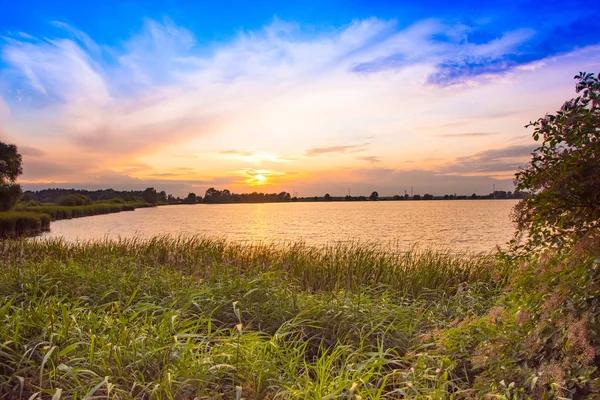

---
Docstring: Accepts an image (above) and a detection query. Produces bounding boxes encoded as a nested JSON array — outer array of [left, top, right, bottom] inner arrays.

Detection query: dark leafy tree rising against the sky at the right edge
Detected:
[[513, 72, 600, 248]]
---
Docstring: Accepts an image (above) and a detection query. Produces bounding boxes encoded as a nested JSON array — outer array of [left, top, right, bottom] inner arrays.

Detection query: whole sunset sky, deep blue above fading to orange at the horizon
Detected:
[[0, 0, 600, 196]]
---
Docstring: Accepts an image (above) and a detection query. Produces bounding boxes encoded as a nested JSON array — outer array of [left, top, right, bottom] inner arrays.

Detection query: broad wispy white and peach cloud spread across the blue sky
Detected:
[[0, 18, 600, 194]]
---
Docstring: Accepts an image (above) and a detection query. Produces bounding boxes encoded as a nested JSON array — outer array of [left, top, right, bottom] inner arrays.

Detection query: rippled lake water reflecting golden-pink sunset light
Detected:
[[42, 200, 517, 252]]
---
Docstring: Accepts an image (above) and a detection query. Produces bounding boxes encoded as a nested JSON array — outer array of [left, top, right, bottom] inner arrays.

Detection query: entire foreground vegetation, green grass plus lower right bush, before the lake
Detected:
[[0, 238, 600, 399]]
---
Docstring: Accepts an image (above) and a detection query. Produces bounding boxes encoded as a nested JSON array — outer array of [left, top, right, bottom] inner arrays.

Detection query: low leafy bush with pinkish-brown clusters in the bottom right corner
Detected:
[[436, 235, 600, 399]]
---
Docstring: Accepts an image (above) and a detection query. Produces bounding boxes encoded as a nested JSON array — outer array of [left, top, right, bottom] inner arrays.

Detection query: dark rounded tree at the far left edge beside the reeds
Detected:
[[0, 142, 23, 211]]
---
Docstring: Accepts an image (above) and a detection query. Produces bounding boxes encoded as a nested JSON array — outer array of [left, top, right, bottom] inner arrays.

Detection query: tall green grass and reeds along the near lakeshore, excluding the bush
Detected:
[[0, 237, 506, 399]]
